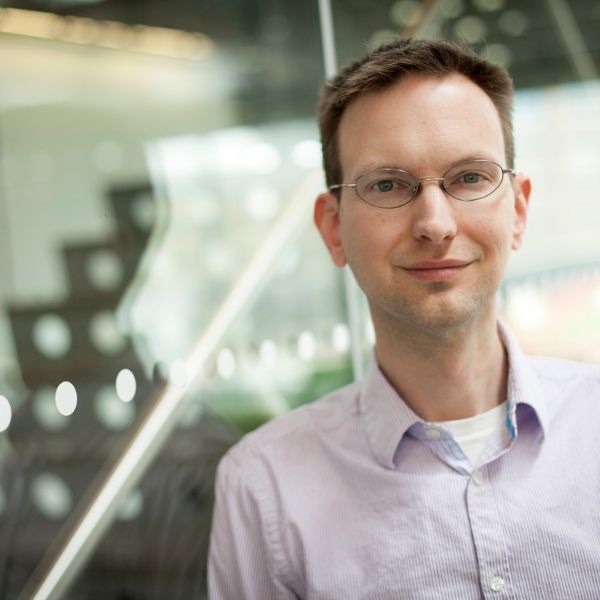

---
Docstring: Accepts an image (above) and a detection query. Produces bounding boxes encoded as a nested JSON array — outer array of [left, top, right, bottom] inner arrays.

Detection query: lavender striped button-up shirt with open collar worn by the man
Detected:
[[209, 329, 600, 600]]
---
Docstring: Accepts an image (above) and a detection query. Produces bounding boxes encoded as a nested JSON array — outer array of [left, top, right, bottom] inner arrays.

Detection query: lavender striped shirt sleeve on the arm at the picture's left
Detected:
[[208, 455, 298, 600]]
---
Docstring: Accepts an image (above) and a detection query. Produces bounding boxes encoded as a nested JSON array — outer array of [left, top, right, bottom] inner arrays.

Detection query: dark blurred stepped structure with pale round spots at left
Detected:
[[0, 183, 240, 600]]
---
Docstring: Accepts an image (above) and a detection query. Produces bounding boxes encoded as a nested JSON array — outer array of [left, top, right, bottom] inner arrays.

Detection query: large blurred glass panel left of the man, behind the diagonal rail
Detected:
[[0, 1, 351, 600]]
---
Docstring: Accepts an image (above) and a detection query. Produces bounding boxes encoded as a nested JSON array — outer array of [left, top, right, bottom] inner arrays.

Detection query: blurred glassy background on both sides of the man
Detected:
[[0, 0, 600, 600]]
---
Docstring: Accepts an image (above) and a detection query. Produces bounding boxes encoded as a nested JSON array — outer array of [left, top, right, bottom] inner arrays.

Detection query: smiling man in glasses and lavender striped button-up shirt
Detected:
[[209, 41, 600, 600]]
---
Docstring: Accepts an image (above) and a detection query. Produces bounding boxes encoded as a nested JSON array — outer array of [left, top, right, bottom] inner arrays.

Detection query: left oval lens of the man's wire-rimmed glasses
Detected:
[[356, 169, 417, 208]]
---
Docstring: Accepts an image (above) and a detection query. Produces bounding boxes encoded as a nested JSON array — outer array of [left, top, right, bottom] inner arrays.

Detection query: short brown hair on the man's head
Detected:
[[319, 40, 514, 186]]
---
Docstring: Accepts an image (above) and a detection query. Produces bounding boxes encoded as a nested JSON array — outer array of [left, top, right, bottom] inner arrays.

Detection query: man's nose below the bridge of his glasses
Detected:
[[411, 177, 458, 244]]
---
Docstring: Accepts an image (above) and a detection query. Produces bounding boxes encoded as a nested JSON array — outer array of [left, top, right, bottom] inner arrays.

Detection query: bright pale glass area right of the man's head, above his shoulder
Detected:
[[502, 81, 600, 362]]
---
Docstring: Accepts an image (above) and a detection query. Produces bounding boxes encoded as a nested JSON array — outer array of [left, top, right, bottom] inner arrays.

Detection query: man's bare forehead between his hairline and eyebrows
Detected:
[[338, 74, 504, 177]]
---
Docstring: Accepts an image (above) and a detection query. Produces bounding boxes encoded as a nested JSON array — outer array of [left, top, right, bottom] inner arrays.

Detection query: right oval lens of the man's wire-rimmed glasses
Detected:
[[444, 160, 503, 202]]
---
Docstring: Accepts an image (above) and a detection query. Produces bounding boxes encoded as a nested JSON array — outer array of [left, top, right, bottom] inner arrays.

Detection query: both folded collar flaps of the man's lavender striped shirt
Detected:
[[359, 322, 548, 469]]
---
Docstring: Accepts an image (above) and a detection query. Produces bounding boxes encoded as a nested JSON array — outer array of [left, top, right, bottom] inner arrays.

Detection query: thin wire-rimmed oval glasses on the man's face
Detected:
[[329, 159, 515, 208]]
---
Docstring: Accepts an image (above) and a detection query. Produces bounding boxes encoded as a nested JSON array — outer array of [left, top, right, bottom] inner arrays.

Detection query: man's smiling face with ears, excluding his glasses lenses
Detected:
[[315, 75, 530, 336]]
